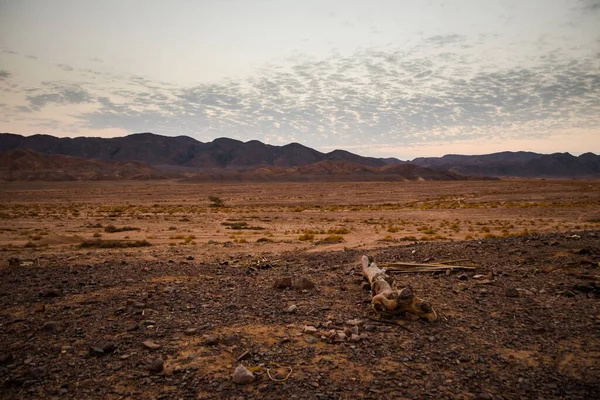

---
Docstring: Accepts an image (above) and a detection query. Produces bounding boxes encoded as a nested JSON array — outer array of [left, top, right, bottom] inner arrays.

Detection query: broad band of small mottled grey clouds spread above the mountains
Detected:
[[5, 35, 600, 151]]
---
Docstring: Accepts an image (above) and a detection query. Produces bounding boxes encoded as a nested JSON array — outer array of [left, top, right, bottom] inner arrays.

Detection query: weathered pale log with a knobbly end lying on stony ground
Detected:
[[362, 256, 437, 322]]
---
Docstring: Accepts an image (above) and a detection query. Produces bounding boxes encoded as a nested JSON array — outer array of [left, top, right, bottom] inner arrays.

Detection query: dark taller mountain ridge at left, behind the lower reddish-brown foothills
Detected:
[[0, 133, 400, 170]]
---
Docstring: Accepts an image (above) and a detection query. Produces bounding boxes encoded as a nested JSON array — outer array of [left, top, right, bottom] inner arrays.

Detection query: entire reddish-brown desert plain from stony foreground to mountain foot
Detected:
[[0, 179, 600, 399]]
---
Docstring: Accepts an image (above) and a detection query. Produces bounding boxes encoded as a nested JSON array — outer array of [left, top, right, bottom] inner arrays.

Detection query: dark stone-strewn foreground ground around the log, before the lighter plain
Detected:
[[0, 231, 600, 399]]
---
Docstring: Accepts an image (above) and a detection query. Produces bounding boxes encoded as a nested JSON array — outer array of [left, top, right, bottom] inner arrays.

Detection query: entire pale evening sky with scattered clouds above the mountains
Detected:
[[0, 0, 600, 160]]
